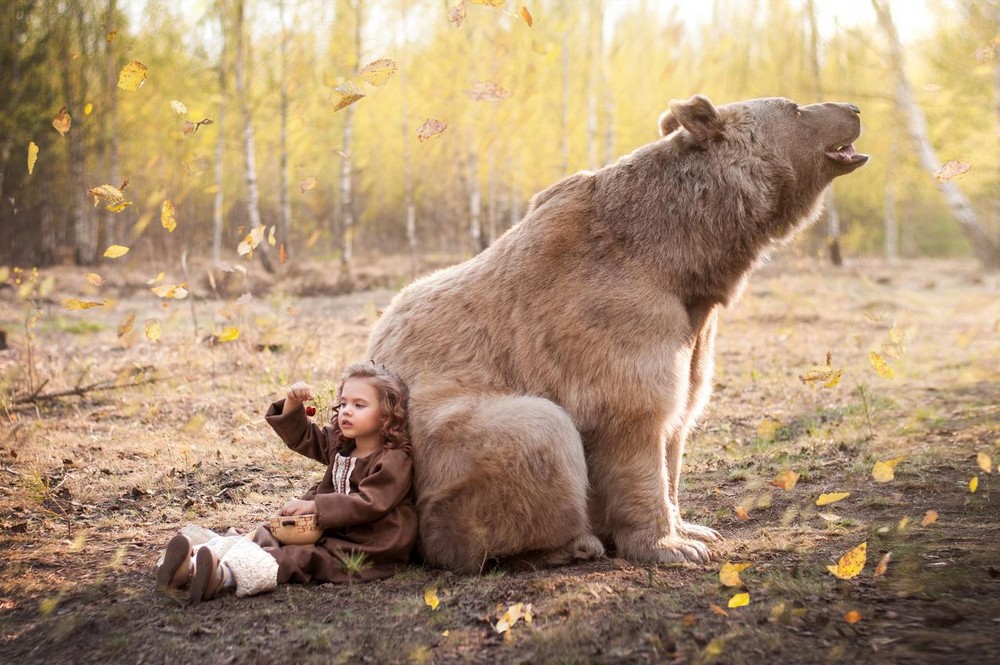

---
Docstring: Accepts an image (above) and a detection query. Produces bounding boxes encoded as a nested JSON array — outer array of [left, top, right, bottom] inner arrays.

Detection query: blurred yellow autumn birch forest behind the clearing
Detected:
[[0, 0, 1000, 278]]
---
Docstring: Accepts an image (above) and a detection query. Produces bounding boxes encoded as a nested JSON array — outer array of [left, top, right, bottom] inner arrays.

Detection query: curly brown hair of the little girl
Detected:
[[332, 361, 413, 455]]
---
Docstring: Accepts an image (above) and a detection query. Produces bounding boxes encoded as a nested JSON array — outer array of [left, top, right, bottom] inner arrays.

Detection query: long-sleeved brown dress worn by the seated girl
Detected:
[[253, 400, 417, 584]]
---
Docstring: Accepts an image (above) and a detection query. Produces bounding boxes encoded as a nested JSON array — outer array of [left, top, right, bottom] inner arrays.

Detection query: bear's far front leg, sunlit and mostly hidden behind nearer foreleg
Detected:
[[667, 309, 722, 542]]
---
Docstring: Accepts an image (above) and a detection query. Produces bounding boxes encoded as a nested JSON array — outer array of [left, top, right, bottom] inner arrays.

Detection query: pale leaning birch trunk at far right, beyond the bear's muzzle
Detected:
[[871, 0, 1000, 269]]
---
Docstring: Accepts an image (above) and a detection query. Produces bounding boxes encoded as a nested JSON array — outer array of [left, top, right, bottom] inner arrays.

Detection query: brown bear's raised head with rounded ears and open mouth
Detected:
[[659, 95, 868, 188]]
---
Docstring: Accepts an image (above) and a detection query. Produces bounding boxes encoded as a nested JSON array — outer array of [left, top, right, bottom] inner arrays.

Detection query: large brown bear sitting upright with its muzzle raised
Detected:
[[368, 96, 868, 572]]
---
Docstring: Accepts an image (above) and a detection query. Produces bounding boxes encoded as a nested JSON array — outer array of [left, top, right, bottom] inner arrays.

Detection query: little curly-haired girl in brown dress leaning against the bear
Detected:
[[157, 363, 417, 602]]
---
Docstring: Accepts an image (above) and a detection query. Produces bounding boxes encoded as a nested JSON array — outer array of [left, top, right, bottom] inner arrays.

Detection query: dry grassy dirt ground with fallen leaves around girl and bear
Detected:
[[0, 253, 1000, 665]]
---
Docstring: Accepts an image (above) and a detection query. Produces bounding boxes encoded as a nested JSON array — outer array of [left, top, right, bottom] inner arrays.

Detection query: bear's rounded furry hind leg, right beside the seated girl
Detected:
[[411, 394, 604, 573]]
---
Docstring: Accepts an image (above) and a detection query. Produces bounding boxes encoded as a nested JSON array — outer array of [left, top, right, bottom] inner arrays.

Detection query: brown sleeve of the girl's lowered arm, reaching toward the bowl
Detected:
[[315, 450, 413, 529]]
